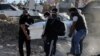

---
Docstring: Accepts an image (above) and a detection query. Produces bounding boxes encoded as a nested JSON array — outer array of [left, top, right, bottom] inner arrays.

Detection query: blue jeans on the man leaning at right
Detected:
[[70, 29, 86, 54]]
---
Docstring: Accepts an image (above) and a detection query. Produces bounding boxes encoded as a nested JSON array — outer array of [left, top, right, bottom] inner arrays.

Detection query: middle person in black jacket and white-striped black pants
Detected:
[[42, 8, 65, 56]]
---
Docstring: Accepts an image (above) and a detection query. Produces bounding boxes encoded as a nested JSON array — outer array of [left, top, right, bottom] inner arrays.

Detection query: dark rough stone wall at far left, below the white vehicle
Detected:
[[0, 21, 19, 44]]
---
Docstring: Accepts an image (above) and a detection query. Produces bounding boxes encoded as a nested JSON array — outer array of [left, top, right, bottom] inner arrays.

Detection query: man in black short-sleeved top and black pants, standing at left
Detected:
[[18, 10, 32, 56]]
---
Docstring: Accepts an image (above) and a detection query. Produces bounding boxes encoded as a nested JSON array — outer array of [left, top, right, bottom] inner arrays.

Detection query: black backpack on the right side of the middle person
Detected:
[[49, 17, 65, 36]]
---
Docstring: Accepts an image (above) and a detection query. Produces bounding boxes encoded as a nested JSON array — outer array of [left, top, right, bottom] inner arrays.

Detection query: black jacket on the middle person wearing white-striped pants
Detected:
[[44, 19, 65, 39]]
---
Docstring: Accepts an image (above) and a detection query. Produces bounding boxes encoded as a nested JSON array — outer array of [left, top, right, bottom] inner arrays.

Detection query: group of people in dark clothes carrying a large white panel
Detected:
[[18, 8, 88, 56]]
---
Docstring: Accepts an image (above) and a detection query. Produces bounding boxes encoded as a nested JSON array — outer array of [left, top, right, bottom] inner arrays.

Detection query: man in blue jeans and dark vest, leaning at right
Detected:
[[67, 8, 87, 56]]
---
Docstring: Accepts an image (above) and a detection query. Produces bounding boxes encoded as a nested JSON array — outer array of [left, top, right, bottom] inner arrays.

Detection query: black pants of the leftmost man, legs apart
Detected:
[[18, 35, 31, 56]]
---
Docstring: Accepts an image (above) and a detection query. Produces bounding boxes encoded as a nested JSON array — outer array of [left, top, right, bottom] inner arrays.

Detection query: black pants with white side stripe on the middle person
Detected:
[[44, 39, 57, 56]]
